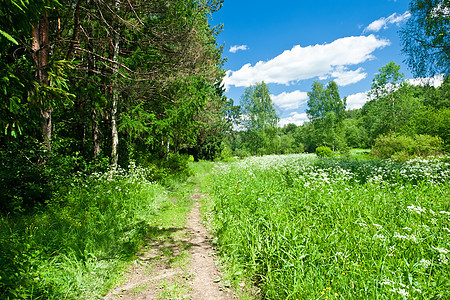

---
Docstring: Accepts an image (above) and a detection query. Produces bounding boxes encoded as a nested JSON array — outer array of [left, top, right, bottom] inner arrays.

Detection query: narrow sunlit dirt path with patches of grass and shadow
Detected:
[[104, 193, 235, 300]]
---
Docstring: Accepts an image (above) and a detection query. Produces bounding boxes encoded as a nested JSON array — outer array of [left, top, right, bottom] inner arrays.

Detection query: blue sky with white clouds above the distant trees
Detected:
[[212, 0, 412, 125]]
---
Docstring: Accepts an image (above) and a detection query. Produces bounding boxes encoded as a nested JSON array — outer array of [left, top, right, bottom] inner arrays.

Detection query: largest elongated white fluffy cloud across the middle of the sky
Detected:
[[224, 35, 389, 87]]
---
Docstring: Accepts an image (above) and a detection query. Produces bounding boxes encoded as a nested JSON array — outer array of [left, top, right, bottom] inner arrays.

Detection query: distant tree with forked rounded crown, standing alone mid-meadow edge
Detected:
[[306, 81, 347, 151]]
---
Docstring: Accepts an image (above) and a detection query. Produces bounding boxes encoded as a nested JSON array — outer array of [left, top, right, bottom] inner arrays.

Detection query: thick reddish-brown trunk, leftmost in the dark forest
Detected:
[[31, 10, 53, 151]]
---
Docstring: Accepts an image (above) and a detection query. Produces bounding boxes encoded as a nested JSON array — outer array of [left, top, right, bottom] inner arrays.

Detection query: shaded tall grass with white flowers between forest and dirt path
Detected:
[[0, 167, 172, 299]]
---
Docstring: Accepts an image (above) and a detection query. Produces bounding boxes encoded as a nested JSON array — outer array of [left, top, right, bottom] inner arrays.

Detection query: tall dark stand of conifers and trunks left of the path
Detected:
[[0, 0, 229, 211]]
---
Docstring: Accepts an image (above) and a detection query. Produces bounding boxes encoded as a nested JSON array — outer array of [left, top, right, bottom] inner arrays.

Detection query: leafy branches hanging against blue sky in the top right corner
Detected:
[[400, 0, 450, 77]]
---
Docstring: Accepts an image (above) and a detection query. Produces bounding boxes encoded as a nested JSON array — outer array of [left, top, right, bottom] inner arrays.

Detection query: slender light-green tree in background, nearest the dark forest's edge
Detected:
[[240, 82, 279, 154]]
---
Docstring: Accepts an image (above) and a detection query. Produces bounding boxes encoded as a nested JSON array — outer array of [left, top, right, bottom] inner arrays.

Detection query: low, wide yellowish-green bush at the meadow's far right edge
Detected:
[[371, 134, 444, 161]]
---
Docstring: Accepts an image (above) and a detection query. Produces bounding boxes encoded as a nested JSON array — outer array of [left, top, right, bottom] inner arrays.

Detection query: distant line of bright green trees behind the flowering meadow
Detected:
[[228, 62, 450, 157]]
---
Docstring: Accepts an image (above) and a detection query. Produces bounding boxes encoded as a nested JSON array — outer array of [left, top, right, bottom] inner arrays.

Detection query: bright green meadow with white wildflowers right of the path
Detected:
[[211, 155, 450, 299]]
